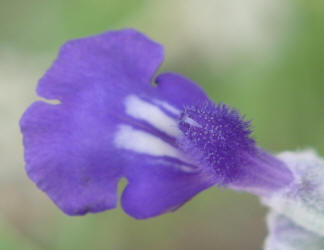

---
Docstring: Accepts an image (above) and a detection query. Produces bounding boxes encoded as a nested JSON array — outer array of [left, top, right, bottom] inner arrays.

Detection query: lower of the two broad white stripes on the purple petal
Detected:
[[114, 125, 179, 158]]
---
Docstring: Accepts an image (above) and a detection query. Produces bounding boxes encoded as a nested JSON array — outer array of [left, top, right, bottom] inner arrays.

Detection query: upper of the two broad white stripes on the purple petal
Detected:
[[125, 95, 180, 136]]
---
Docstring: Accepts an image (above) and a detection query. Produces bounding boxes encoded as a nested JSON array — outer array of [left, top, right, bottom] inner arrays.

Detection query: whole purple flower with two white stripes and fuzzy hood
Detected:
[[20, 30, 292, 218]]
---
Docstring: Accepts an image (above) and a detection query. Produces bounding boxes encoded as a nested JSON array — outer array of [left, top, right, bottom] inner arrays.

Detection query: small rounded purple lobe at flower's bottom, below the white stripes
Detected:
[[121, 156, 216, 219]]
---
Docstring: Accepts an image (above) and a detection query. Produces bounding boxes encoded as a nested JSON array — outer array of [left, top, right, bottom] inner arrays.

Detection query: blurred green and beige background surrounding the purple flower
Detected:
[[0, 0, 324, 250]]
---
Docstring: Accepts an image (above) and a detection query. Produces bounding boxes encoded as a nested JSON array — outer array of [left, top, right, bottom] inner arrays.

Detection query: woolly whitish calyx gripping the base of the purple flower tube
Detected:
[[262, 150, 324, 236]]
